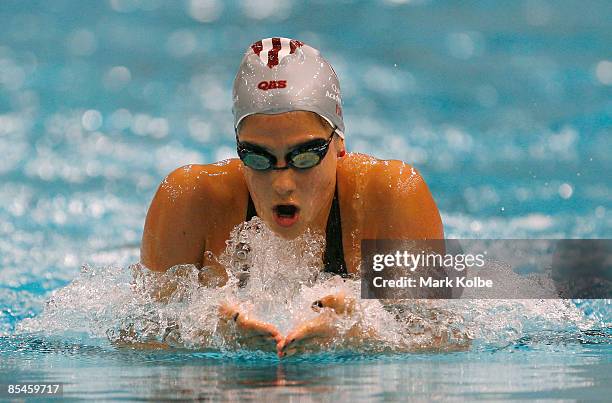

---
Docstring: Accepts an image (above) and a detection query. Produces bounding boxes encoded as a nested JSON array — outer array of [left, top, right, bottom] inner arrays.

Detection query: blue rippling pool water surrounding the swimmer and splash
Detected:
[[0, 0, 612, 400]]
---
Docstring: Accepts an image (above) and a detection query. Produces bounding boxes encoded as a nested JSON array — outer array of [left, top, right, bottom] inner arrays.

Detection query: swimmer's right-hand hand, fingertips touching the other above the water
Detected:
[[277, 292, 355, 357]]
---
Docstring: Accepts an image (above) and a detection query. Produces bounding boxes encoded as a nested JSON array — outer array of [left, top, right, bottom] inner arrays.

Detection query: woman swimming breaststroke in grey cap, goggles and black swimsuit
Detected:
[[141, 38, 444, 356]]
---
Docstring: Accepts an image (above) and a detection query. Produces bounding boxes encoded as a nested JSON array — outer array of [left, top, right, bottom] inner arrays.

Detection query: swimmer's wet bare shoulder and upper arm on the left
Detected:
[[141, 160, 248, 271]]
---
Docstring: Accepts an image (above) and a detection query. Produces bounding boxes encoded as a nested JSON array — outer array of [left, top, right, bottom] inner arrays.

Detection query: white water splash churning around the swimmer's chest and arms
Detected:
[[16, 217, 609, 352]]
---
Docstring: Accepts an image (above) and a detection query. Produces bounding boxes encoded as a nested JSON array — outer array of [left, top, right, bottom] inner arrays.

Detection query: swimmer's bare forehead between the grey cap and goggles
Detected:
[[239, 111, 331, 148]]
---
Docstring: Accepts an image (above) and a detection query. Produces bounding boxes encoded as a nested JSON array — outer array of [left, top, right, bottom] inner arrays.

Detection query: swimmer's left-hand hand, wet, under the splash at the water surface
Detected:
[[219, 303, 283, 351]]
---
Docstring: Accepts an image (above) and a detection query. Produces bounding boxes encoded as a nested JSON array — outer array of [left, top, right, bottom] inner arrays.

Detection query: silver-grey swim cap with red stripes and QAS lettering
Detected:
[[232, 38, 344, 138]]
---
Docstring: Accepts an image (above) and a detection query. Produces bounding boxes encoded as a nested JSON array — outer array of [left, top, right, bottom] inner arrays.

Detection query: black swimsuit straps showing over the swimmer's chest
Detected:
[[246, 187, 348, 276]]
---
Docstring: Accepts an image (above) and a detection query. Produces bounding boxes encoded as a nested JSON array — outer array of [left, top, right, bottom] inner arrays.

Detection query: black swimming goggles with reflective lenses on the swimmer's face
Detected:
[[236, 127, 336, 171]]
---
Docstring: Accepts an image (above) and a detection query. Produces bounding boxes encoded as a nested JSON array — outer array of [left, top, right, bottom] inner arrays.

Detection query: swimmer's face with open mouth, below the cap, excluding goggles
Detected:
[[238, 111, 344, 239]]
